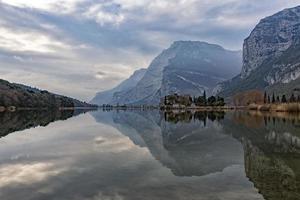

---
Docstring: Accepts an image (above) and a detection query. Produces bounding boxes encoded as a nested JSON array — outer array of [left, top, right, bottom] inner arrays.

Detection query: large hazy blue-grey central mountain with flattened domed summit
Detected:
[[108, 41, 242, 105]]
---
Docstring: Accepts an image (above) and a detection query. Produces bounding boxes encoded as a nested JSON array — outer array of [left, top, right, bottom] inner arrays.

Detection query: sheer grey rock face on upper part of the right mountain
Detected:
[[241, 7, 300, 78]]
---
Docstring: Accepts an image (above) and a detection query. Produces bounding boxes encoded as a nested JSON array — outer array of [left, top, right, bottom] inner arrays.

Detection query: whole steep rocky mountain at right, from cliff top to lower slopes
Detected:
[[215, 6, 300, 97]]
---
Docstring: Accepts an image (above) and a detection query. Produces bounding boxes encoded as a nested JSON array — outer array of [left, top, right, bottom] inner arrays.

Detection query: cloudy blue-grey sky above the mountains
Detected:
[[0, 0, 300, 101]]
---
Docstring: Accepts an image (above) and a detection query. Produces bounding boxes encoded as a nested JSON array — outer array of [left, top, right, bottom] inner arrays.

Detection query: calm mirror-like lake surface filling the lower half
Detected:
[[0, 111, 300, 200]]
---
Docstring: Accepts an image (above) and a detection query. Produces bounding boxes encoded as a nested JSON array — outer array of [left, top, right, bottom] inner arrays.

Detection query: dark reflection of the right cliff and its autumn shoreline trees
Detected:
[[224, 113, 300, 200]]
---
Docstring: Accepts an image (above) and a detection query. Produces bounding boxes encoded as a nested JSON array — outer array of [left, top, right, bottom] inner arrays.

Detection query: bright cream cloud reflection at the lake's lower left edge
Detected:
[[0, 163, 63, 187]]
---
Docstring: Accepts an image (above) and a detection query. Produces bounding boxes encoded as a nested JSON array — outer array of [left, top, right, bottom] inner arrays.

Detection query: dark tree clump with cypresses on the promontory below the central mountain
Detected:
[[160, 91, 225, 107]]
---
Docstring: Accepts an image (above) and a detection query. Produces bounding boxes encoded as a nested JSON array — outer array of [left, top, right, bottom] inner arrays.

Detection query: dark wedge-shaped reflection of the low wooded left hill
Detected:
[[0, 110, 91, 137]]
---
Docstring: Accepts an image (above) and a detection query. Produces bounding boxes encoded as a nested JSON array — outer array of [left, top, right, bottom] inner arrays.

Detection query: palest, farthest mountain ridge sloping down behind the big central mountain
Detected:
[[91, 69, 146, 105]]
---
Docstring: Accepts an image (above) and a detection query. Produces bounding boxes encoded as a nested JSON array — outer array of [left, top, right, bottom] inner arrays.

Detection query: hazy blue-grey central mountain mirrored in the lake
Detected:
[[92, 111, 243, 176]]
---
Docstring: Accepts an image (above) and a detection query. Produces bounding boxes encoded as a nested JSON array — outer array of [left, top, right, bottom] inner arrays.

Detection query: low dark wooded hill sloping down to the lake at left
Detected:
[[0, 79, 94, 108]]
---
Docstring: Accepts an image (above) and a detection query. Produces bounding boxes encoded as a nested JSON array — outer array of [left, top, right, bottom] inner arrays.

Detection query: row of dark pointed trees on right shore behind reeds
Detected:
[[264, 92, 300, 104]]
